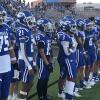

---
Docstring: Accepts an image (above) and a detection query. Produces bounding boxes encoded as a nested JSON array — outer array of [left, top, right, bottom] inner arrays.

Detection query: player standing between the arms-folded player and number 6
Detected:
[[75, 19, 85, 88]]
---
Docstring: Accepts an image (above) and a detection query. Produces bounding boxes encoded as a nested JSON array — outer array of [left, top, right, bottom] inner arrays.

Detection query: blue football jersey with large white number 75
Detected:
[[0, 24, 12, 56]]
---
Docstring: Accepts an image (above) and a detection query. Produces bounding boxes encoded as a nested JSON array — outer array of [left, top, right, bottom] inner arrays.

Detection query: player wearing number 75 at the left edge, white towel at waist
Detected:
[[0, 6, 18, 100]]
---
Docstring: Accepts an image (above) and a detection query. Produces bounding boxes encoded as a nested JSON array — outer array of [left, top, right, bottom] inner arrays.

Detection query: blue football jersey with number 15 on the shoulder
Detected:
[[35, 32, 52, 56]]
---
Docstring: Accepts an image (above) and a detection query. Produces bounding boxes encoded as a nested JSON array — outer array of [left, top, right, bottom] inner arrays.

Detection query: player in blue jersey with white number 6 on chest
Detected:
[[84, 20, 96, 88]]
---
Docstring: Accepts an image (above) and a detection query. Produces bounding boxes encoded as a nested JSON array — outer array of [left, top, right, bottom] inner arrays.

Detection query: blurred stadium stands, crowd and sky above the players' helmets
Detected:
[[0, 0, 100, 20]]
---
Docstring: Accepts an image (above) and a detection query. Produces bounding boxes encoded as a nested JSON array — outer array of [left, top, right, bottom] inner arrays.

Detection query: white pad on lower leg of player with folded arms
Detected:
[[64, 80, 75, 95]]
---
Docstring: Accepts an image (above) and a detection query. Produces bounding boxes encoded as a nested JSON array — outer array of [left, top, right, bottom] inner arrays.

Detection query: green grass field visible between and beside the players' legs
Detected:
[[29, 59, 100, 100]]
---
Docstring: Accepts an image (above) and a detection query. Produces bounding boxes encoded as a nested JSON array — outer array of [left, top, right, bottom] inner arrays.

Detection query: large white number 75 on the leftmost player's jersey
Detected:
[[0, 36, 9, 52]]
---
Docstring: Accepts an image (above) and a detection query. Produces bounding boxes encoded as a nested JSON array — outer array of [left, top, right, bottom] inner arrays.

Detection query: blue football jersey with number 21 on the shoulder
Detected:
[[16, 25, 33, 57]]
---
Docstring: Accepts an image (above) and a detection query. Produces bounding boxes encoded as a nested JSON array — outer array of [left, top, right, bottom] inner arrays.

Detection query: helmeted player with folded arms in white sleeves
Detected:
[[58, 19, 77, 100]]
